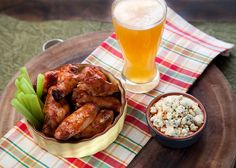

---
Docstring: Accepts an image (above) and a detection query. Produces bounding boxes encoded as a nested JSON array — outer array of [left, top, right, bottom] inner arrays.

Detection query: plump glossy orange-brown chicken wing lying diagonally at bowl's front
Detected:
[[54, 103, 99, 140]]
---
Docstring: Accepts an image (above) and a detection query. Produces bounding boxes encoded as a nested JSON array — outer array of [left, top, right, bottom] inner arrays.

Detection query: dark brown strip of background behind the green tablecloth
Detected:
[[0, 0, 236, 22]]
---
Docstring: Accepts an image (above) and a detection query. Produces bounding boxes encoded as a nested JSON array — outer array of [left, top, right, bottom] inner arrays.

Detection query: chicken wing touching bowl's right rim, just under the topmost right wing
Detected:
[[72, 88, 121, 112]]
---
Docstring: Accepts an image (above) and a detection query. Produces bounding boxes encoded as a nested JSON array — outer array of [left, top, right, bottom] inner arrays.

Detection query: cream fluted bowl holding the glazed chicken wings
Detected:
[[26, 64, 127, 158]]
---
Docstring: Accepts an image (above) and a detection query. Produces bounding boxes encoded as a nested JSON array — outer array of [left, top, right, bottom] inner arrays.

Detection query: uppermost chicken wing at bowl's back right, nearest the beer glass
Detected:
[[77, 77, 119, 96]]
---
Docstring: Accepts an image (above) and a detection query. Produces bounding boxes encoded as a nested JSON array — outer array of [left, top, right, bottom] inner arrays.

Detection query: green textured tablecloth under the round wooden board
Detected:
[[0, 15, 236, 94]]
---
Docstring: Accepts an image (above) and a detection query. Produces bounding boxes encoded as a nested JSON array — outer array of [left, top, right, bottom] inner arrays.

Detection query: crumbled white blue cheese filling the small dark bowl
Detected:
[[150, 95, 204, 137]]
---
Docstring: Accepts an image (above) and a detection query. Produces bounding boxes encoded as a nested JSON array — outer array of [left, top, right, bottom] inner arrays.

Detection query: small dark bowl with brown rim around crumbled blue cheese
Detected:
[[146, 92, 207, 148]]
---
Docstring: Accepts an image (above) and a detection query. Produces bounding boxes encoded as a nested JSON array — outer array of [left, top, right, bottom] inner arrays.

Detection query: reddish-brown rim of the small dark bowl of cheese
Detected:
[[146, 92, 207, 140]]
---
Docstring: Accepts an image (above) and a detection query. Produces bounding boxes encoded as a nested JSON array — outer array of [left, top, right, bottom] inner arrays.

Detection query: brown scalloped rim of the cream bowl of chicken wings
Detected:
[[26, 63, 127, 144]]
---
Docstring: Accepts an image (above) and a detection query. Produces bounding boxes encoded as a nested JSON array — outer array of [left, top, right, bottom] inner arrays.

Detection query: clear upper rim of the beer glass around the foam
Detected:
[[112, 0, 167, 30]]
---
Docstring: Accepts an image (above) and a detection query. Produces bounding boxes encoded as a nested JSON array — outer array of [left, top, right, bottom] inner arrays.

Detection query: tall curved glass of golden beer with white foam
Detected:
[[112, 0, 167, 93]]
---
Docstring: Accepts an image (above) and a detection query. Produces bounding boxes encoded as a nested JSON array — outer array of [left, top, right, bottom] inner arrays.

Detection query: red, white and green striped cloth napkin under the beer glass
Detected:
[[0, 9, 233, 167]]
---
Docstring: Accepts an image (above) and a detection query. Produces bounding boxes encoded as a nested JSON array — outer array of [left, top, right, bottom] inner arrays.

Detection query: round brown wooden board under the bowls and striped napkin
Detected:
[[0, 32, 236, 167]]
